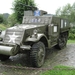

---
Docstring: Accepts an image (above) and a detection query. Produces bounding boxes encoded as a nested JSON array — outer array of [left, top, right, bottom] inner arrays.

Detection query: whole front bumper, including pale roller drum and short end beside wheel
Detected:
[[0, 42, 31, 56]]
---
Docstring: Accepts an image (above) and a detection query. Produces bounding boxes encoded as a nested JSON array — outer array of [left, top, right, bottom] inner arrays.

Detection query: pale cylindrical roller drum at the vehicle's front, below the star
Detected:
[[0, 43, 19, 56]]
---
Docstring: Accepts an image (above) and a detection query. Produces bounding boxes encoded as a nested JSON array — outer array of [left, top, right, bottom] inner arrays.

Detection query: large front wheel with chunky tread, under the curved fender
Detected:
[[30, 42, 45, 67]]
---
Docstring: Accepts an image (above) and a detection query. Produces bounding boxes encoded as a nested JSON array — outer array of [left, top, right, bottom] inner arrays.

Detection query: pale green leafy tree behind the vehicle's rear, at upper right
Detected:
[[56, 3, 75, 23]]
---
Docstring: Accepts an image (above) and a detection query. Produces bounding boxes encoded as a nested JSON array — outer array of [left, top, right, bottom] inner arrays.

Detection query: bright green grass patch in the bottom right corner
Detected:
[[40, 66, 75, 75]]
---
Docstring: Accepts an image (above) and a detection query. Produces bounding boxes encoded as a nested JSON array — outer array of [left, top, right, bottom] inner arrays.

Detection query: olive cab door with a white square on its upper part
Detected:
[[48, 24, 59, 46]]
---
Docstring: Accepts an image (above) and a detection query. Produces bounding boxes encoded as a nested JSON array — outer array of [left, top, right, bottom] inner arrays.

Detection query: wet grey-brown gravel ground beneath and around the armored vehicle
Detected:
[[0, 44, 75, 75]]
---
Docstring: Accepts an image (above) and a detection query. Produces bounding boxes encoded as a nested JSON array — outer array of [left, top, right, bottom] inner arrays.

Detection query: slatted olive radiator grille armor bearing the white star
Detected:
[[3, 29, 24, 45]]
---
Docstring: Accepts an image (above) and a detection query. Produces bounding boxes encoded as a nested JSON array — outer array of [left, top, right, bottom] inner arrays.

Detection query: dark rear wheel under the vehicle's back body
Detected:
[[55, 35, 68, 49]]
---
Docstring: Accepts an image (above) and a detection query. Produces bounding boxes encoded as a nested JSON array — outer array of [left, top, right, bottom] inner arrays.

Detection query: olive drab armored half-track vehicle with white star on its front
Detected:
[[0, 10, 70, 67]]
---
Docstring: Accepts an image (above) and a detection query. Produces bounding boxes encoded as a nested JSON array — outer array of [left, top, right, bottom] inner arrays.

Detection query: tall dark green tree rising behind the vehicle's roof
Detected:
[[13, 0, 35, 23]]
